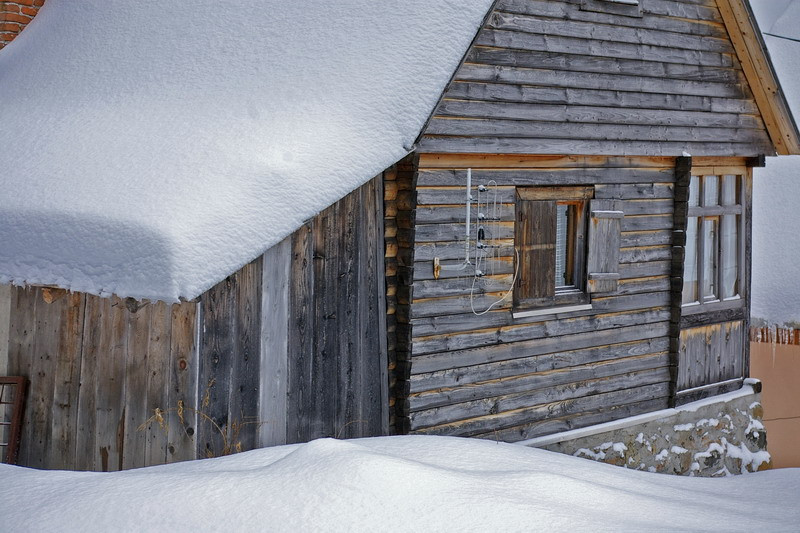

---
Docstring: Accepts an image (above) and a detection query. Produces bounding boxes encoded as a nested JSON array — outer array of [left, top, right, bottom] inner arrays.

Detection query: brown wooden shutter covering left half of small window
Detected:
[[514, 199, 556, 302]]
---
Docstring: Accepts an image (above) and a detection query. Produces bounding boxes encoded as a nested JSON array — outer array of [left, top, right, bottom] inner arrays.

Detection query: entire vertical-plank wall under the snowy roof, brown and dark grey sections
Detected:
[[0, 176, 389, 471]]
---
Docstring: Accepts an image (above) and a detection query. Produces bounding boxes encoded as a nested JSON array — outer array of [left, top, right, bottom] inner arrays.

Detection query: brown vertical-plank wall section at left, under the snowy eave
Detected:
[[9, 287, 198, 471]]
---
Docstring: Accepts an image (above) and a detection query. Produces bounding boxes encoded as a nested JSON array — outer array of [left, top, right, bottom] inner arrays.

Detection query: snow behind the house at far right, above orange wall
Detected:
[[750, 0, 800, 325]]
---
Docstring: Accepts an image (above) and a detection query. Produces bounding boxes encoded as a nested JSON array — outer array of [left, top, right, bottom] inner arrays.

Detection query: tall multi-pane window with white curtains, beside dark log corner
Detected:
[[682, 173, 744, 312]]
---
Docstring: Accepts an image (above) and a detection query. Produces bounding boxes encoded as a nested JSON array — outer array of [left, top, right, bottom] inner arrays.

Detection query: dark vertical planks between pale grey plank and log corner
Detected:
[[276, 175, 389, 444]]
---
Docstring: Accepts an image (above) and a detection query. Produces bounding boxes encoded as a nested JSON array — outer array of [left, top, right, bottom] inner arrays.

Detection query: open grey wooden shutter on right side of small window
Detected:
[[586, 200, 623, 293]]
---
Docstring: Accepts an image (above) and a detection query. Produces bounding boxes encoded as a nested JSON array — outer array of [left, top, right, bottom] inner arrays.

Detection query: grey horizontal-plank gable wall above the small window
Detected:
[[420, 0, 774, 156]]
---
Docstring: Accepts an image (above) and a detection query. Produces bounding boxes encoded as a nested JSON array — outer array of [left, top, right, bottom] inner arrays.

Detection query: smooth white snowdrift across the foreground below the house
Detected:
[[0, 436, 800, 532]]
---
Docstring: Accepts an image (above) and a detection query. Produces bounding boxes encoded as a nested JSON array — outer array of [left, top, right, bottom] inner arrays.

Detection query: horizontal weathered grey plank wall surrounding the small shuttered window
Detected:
[[398, 154, 676, 441]]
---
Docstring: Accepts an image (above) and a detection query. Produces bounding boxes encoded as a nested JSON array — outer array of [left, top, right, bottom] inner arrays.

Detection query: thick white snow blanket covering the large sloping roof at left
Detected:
[[0, 0, 491, 300]]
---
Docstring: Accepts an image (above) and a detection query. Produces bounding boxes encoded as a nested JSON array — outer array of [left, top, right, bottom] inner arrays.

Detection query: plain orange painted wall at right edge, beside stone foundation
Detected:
[[750, 342, 800, 468]]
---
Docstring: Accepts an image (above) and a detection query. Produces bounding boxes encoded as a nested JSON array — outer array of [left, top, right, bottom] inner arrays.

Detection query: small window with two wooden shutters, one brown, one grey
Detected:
[[514, 187, 622, 315]]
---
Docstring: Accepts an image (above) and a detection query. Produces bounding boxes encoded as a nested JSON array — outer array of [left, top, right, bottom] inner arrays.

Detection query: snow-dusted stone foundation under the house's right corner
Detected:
[[523, 380, 771, 477]]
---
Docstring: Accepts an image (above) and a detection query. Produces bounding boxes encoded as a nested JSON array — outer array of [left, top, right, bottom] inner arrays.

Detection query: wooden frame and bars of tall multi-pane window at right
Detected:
[[681, 167, 749, 315]]
